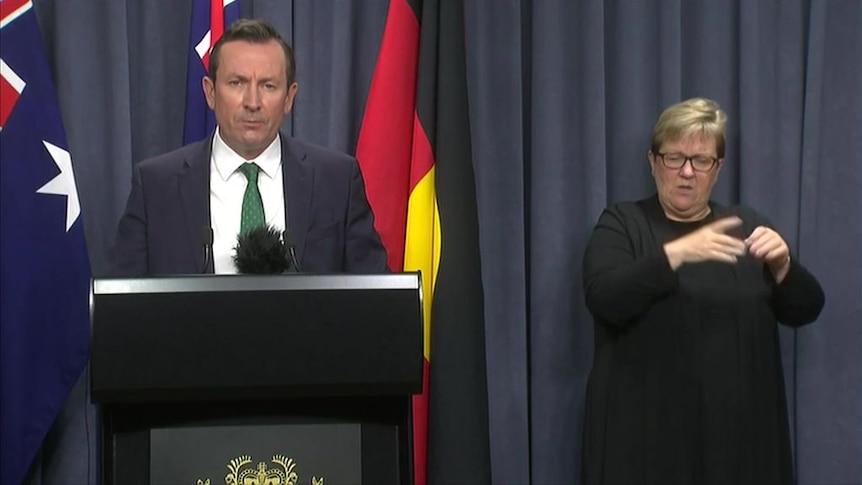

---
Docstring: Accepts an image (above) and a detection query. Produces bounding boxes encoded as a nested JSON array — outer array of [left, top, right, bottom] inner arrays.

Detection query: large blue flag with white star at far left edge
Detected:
[[0, 0, 90, 483]]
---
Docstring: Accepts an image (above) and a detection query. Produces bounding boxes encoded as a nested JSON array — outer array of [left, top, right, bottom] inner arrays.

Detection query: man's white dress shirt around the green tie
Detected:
[[210, 128, 284, 274]]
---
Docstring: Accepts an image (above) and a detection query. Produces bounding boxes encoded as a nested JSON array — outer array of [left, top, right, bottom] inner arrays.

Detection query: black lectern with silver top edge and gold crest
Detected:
[[90, 273, 422, 485]]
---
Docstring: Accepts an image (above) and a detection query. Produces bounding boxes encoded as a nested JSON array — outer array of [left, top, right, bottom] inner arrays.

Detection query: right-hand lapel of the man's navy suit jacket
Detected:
[[279, 133, 314, 261]]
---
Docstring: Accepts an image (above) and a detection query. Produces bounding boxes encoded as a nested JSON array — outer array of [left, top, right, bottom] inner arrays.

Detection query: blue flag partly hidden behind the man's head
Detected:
[[183, 0, 240, 144]]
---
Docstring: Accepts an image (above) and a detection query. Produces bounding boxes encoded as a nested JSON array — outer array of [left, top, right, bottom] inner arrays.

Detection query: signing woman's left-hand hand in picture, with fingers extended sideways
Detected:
[[664, 217, 746, 270]]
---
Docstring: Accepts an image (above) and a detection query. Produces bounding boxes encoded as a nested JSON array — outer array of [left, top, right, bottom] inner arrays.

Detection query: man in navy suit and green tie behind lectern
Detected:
[[111, 19, 386, 276]]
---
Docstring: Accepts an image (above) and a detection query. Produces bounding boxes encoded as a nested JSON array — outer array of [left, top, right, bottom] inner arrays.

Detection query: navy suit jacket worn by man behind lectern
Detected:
[[111, 134, 387, 276]]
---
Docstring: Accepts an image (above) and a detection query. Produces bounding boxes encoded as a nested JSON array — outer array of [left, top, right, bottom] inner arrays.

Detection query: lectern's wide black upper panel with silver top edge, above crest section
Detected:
[[91, 274, 422, 402]]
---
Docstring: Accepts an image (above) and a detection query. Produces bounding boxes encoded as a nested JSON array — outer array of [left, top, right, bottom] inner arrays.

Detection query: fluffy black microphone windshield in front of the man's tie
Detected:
[[233, 226, 290, 274]]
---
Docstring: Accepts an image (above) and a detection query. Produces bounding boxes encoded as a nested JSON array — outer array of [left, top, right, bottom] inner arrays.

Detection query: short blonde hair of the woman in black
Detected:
[[650, 98, 727, 158]]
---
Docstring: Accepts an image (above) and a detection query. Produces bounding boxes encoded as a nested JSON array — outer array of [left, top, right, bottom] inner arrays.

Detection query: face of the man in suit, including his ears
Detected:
[[203, 40, 298, 160]]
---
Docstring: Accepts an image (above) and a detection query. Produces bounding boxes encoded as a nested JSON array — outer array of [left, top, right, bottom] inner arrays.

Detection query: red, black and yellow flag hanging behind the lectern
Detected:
[[357, 0, 491, 485]]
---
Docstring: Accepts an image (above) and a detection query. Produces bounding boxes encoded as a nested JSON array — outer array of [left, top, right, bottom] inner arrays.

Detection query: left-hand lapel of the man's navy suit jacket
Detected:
[[177, 136, 212, 273]]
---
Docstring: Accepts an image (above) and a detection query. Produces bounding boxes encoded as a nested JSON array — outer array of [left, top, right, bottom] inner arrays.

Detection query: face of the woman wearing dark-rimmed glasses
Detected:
[[649, 136, 724, 221]]
